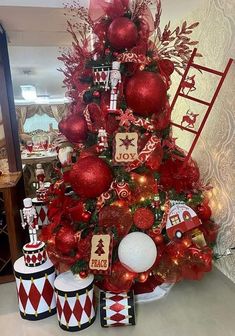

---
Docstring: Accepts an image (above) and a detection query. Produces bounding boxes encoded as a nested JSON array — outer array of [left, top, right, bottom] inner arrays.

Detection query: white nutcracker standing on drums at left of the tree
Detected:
[[20, 198, 39, 245]]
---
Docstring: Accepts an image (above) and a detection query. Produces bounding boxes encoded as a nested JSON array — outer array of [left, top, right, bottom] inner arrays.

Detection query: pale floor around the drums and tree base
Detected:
[[0, 269, 235, 336]]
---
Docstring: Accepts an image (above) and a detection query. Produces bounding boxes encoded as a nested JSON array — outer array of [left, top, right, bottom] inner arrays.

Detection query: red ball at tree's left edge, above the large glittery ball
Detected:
[[58, 114, 87, 143]]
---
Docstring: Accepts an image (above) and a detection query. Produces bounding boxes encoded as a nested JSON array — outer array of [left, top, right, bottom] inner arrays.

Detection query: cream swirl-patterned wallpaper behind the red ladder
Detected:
[[171, 0, 235, 282]]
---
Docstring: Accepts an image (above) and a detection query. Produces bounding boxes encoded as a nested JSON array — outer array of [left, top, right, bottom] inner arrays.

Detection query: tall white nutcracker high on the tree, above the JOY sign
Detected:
[[106, 61, 121, 111]]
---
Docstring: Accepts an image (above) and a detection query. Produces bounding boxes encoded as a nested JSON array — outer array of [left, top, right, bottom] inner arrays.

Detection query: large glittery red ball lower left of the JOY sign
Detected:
[[70, 156, 113, 198]]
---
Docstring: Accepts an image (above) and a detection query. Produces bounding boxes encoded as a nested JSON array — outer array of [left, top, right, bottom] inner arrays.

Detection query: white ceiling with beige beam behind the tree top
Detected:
[[0, 0, 203, 99]]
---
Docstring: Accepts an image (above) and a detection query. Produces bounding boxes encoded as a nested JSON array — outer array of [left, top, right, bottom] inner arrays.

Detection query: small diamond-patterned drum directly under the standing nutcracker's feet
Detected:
[[23, 242, 47, 267]]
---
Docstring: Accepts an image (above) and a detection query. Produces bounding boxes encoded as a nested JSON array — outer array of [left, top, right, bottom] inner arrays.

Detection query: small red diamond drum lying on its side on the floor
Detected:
[[100, 291, 135, 327]]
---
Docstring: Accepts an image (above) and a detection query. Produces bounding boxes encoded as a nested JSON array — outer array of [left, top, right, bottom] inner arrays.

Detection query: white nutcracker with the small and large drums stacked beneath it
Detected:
[[14, 198, 56, 320]]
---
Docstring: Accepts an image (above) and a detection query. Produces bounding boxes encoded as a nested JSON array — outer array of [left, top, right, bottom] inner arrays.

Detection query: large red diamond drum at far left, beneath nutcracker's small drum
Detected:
[[14, 257, 56, 320]]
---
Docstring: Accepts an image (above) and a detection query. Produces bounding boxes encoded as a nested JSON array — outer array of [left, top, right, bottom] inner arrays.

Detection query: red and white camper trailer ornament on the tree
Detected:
[[166, 203, 201, 239]]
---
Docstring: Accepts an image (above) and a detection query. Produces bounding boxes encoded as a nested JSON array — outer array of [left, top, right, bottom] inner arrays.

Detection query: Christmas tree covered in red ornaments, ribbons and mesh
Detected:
[[41, 0, 218, 293]]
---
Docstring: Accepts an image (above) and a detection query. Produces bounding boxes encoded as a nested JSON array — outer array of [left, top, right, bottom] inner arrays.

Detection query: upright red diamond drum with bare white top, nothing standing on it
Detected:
[[54, 271, 95, 331]]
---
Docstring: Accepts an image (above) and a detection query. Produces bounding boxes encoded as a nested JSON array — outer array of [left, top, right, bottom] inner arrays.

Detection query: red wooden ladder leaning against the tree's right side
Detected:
[[171, 48, 233, 168]]
